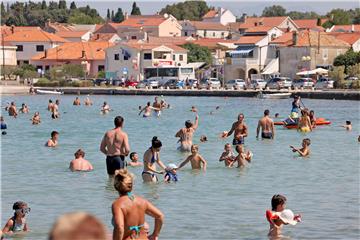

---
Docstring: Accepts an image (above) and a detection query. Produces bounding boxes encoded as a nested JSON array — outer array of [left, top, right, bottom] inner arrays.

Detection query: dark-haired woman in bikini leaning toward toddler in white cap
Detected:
[[142, 137, 166, 182]]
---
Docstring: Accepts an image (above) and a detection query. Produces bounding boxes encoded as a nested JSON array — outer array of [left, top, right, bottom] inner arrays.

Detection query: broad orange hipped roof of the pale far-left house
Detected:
[[5, 30, 68, 42]]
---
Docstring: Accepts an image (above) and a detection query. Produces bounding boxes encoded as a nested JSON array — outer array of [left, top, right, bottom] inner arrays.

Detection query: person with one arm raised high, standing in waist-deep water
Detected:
[[175, 114, 199, 152]]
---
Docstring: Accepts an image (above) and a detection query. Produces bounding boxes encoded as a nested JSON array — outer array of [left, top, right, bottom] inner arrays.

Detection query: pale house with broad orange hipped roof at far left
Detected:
[[4, 30, 68, 65]]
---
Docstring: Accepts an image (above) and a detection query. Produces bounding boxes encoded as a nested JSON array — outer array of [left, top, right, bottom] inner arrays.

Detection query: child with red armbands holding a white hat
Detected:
[[266, 194, 301, 239]]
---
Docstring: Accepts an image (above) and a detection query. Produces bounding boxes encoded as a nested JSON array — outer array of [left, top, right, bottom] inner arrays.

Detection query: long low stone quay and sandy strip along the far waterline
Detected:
[[0, 85, 360, 101]]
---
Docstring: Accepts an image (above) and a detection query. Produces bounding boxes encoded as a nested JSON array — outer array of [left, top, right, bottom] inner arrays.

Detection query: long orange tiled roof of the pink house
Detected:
[[31, 42, 114, 61]]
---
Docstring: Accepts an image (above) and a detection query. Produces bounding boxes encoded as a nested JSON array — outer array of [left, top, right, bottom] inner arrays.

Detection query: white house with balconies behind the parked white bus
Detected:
[[105, 42, 187, 80]]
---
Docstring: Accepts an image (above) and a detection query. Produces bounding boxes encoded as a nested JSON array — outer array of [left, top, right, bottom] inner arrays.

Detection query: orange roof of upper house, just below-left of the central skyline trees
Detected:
[[117, 15, 166, 28]]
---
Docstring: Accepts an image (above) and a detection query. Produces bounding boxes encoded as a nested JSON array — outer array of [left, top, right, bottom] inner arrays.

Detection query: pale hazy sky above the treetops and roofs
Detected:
[[5, 0, 360, 17]]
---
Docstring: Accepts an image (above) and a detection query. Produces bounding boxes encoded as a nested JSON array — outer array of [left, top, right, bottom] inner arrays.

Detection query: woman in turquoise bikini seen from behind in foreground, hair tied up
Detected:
[[111, 169, 164, 240]]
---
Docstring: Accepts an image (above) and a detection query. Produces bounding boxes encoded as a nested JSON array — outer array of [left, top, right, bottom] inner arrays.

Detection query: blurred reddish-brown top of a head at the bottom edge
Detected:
[[49, 212, 107, 240]]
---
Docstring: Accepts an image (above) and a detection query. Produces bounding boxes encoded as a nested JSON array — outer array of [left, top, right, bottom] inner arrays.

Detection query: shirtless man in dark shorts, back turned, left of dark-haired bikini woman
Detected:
[[100, 116, 130, 175]]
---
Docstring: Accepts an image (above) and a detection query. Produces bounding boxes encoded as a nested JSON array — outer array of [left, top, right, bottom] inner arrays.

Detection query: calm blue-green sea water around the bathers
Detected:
[[1, 96, 360, 239]]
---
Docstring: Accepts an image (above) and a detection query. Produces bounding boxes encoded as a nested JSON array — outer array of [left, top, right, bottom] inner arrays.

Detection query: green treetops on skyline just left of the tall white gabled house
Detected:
[[160, 1, 212, 21]]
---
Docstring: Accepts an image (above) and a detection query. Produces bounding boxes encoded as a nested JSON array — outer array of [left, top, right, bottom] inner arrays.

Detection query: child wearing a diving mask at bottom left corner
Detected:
[[2, 201, 31, 234]]
